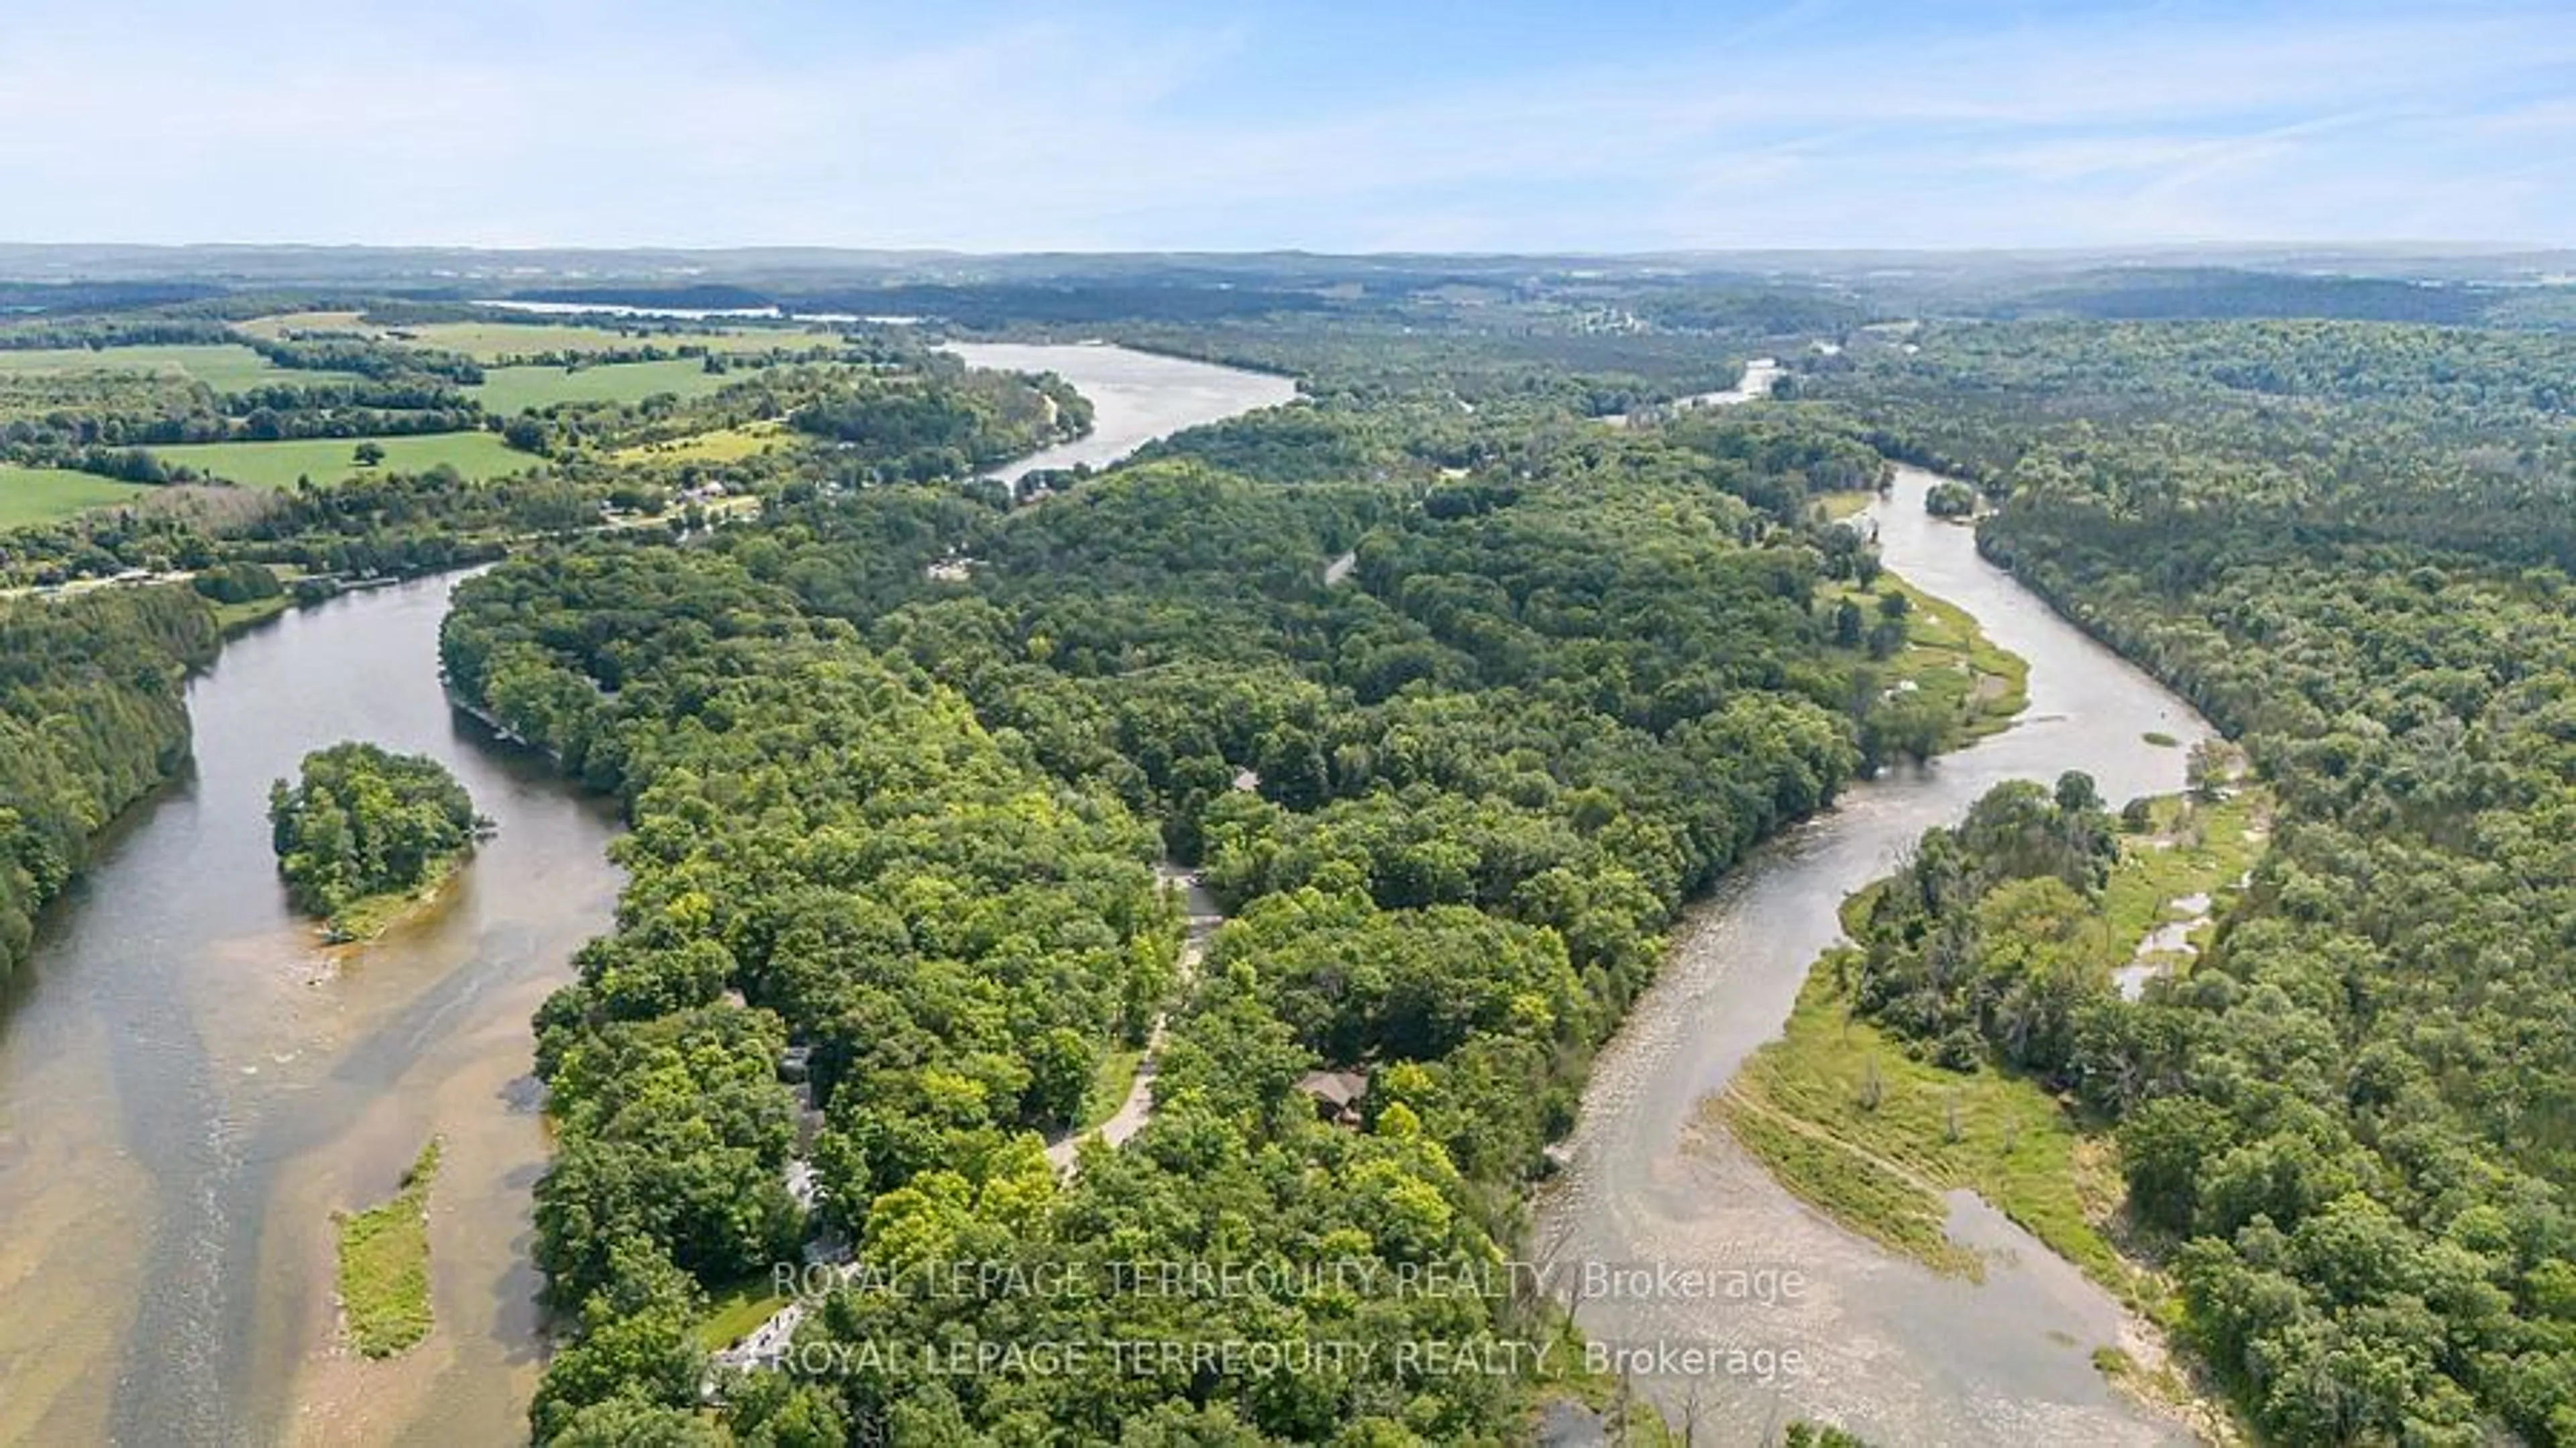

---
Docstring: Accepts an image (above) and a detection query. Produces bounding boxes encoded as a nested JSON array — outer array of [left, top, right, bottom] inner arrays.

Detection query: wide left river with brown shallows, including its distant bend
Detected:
[[0, 345, 1296, 1448]]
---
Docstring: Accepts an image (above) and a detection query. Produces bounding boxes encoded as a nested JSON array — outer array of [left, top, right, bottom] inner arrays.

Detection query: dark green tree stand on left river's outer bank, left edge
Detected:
[[0, 588, 217, 977]]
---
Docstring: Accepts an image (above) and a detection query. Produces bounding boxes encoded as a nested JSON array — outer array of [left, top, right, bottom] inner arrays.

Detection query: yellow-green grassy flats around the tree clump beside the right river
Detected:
[[1705, 786, 2272, 1435]]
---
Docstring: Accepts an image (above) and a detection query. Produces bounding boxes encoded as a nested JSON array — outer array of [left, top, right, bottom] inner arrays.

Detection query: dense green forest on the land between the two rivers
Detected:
[[443, 399, 1957, 1443]]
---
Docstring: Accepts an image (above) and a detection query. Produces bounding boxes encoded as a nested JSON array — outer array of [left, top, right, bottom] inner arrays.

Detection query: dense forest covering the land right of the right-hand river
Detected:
[[1837, 325, 2576, 1443]]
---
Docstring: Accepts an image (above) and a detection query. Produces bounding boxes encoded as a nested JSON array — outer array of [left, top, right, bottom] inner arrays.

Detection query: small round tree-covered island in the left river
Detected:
[[268, 742, 492, 943]]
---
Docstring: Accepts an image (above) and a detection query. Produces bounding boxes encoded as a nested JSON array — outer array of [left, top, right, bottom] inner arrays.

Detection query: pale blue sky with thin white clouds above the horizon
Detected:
[[0, 0, 2576, 252]]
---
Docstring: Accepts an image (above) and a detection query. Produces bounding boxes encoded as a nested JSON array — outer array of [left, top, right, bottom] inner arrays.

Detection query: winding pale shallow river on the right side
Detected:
[[1530, 469, 2210, 1445]]
